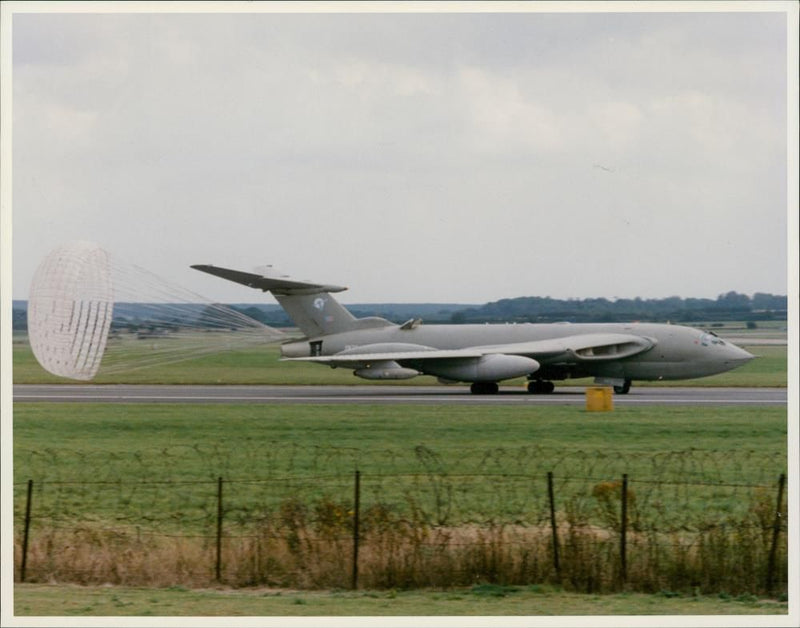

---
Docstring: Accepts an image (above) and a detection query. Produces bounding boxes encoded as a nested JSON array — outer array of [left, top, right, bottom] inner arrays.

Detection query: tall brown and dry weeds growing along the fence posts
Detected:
[[16, 493, 788, 595]]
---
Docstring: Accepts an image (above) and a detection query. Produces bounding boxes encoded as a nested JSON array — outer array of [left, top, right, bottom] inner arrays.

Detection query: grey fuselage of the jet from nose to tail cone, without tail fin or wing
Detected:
[[281, 319, 753, 380]]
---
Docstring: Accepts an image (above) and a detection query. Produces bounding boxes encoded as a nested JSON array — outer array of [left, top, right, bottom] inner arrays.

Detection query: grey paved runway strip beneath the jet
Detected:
[[14, 385, 787, 407]]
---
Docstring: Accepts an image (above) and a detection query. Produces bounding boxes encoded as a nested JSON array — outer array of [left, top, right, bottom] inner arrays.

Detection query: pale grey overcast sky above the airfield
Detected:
[[4, 4, 796, 303]]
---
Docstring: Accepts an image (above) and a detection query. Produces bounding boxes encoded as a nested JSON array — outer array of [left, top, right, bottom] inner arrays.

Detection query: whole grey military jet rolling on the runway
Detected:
[[192, 265, 754, 394]]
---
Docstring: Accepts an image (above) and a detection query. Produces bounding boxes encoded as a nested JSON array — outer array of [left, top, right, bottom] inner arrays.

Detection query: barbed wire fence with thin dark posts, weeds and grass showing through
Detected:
[[14, 466, 788, 595]]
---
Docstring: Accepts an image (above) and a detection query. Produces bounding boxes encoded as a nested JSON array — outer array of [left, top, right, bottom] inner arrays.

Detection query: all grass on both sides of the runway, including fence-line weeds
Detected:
[[9, 324, 787, 616]]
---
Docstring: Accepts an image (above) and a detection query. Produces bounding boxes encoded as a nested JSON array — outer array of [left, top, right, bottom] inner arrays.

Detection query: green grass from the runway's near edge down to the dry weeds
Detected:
[[14, 403, 787, 527]]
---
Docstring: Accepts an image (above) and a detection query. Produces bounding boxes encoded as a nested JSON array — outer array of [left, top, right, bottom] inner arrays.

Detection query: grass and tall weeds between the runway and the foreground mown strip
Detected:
[[14, 403, 787, 595]]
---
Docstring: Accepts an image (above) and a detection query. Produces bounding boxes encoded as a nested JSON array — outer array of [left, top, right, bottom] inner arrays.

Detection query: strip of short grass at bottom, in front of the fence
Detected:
[[14, 584, 788, 617]]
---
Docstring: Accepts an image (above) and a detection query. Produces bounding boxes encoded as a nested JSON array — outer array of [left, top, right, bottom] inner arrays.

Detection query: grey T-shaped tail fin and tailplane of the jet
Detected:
[[192, 264, 368, 338]]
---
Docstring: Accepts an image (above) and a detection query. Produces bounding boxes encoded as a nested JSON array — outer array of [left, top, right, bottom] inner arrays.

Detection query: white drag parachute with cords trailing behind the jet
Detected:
[[28, 242, 286, 380]]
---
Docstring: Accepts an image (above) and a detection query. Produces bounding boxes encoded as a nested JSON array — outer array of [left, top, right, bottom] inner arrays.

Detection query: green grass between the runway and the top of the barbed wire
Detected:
[[14, 403, 787, 482]]
